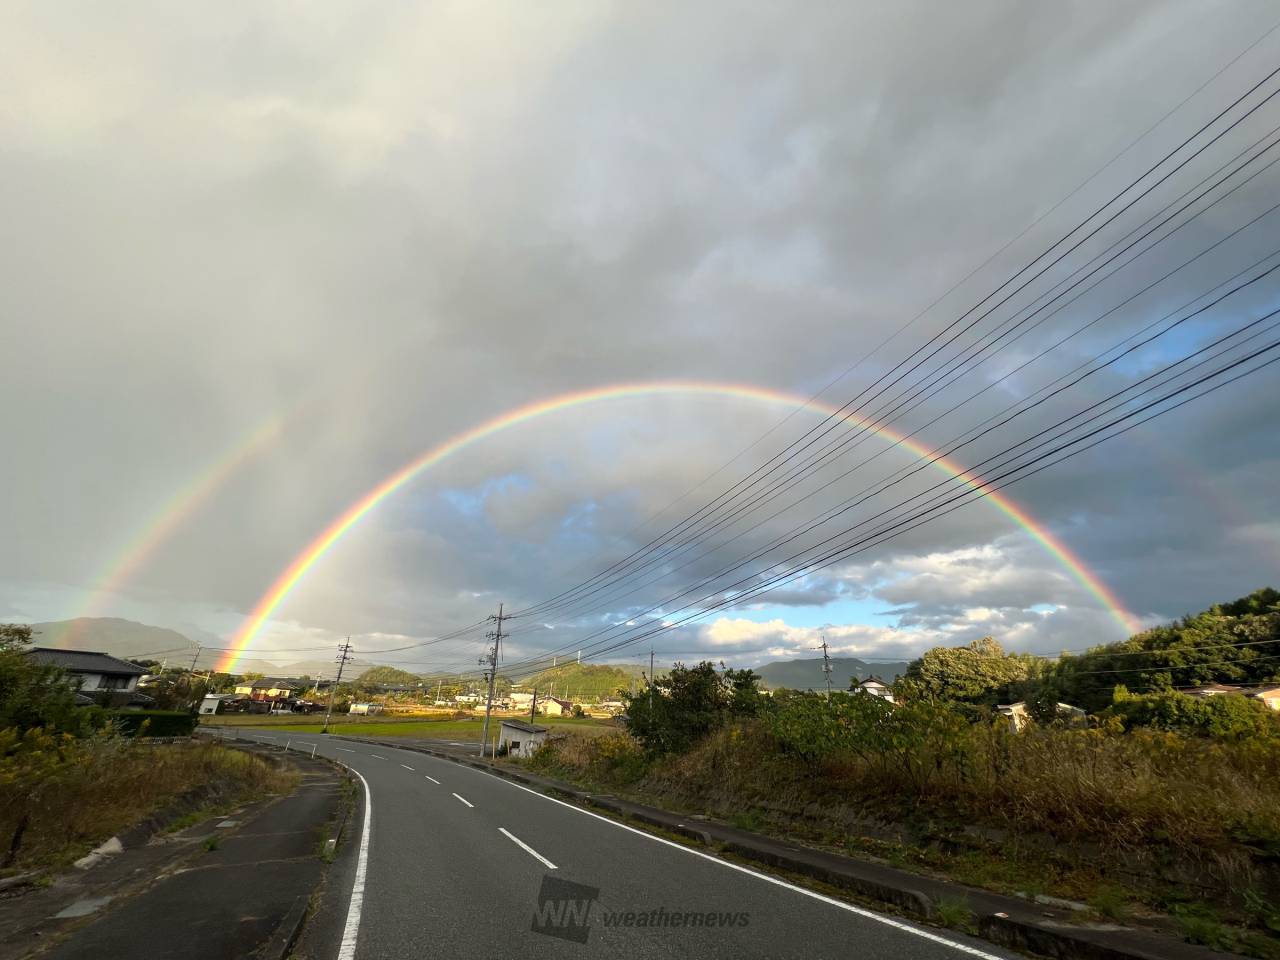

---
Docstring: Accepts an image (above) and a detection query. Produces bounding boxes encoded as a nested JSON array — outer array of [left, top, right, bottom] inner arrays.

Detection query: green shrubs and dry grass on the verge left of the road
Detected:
[[0, 625, 293, 874]]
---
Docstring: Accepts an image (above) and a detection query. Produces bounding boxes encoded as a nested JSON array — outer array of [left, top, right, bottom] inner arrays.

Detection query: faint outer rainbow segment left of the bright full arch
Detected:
[[64, 412, 292, 643]]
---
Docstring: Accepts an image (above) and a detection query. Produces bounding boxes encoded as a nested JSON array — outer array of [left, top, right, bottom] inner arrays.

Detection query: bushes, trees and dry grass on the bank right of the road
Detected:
[[529, 590, 1280, 957]]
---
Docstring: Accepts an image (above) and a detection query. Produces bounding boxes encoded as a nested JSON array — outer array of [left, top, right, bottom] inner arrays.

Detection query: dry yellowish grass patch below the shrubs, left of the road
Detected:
[[0, 731, 296, 870]]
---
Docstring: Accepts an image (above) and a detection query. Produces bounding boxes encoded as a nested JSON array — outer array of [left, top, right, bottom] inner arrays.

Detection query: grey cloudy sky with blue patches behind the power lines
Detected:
[[0, 0, 1280, 671]]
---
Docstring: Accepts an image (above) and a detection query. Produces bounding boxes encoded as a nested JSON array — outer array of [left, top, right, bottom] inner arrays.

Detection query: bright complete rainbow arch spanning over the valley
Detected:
[[218, 381, 1139, 672]]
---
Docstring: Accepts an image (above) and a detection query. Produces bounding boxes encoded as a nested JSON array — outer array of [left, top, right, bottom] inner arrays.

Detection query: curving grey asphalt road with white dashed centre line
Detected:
[[222, 728, 1016, 960]]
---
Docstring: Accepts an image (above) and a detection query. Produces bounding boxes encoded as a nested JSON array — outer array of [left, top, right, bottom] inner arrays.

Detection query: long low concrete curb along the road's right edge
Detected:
[[330, 735, 1240, 960]]
